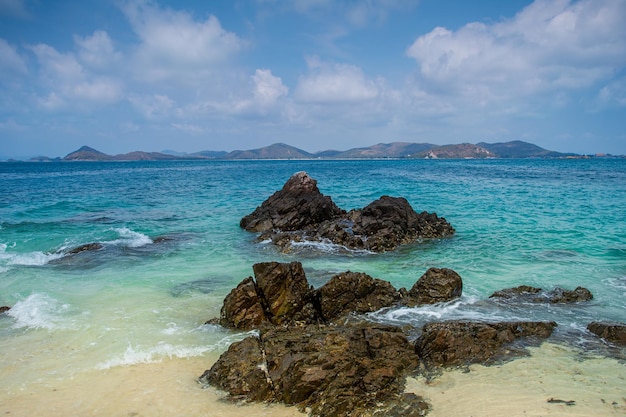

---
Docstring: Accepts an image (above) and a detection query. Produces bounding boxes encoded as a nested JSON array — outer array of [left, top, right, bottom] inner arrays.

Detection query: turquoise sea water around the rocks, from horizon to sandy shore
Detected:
[[0, 159, 626, 412]]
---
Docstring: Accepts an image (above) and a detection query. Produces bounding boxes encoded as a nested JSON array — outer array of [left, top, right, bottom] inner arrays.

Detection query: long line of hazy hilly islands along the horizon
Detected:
[[8, 140, 620, 162]]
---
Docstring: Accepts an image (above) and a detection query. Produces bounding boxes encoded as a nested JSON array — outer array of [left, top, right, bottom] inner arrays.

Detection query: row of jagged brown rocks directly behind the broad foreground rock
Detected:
[[209, 262, 463, 330]]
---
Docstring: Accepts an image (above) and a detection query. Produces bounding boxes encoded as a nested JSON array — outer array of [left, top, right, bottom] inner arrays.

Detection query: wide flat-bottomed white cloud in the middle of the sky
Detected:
[[295, 59, 379, 103]]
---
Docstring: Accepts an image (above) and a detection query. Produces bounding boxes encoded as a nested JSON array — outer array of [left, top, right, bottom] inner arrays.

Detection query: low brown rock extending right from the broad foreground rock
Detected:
[[415, 321, 556, 367]]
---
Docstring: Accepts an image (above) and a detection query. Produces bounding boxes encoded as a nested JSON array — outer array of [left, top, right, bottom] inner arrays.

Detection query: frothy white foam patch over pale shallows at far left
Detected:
[[7, 293, 71, 330]]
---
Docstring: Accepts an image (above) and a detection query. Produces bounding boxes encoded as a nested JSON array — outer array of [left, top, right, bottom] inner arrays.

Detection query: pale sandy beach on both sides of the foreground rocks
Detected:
[[0, 343, 626, 417]]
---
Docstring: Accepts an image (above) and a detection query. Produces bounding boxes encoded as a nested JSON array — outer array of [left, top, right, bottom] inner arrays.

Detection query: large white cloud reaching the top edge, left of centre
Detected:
[[123, 0, 244, 81]]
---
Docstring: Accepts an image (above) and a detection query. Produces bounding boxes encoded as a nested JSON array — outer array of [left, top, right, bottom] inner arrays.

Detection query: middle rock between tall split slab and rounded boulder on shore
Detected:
[[318, 271, 399, 320]]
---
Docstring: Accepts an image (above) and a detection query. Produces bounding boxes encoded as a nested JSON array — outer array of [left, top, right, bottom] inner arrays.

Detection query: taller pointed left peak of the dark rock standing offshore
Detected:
[[240, 172, 345, 232]]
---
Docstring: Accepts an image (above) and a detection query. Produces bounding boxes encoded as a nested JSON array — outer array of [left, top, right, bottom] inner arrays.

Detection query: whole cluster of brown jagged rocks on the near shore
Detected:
[[200, 262, 572, 416]]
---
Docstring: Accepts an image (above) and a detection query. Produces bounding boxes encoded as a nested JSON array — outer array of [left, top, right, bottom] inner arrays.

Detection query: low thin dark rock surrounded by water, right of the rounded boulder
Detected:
[[489, 285, 593, 304]]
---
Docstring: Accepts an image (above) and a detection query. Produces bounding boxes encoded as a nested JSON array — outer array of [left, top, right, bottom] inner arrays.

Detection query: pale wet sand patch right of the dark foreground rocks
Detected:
[[407, 343, 626, 417]]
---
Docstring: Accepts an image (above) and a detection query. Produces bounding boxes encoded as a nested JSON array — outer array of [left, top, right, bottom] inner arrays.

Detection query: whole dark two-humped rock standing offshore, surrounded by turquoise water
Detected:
[[240, 172, 454, 252]]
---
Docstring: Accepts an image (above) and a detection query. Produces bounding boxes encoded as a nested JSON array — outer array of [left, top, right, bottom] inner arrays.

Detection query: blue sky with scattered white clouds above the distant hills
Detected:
[[0, 0, 626, 158]]
